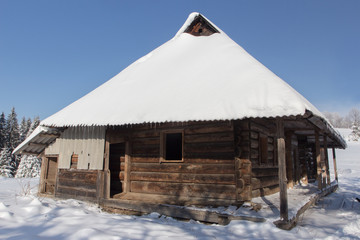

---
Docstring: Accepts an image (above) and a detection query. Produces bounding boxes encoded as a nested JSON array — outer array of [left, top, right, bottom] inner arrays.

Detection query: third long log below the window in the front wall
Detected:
[[131, 181, 235, 200]]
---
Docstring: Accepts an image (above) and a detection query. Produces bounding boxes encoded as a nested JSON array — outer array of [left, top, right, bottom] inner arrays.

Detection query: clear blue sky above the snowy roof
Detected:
[[0, 0, 360, 119]]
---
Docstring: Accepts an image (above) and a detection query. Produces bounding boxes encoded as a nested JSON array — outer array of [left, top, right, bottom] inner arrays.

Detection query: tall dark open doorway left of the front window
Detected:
[[109, 143, 125, 197]]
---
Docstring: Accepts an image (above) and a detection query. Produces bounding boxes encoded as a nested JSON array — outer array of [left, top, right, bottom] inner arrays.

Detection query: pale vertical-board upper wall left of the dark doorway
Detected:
[[45, 127, 105, 170]]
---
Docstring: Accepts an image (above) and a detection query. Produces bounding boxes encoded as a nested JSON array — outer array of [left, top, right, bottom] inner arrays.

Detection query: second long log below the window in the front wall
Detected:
[[130, 172, 235, 185]]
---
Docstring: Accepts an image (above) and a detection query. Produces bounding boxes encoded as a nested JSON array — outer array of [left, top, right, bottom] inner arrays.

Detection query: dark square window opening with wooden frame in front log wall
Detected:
[[160, 131, 184, 162]]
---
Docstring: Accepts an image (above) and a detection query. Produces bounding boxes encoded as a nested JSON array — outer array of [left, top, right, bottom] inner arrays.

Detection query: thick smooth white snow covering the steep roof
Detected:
[[41, 13, 323, 127]]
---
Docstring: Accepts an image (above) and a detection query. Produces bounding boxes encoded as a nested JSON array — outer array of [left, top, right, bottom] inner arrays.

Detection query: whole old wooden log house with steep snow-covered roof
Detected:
[[14, 13, 346, 222]]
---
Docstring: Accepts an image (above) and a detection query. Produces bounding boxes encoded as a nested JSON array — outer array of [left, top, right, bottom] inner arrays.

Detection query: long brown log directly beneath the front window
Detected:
[[131, 163, 234, 174]]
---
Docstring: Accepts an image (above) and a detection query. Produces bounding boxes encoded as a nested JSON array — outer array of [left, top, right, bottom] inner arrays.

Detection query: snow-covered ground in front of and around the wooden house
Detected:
[[0, 129, 360, 240]]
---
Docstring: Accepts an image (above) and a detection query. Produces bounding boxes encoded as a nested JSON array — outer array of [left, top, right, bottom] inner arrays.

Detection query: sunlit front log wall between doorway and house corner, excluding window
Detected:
[[107, 121, 236, 204]]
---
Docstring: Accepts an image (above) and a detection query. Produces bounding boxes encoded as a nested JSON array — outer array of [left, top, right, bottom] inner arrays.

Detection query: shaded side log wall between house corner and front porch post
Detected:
[[235, 119, 279, 201]]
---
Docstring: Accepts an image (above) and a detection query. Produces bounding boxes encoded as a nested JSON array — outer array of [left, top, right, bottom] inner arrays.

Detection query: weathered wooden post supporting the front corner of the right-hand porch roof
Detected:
[[276, 119, 288, 221]]
